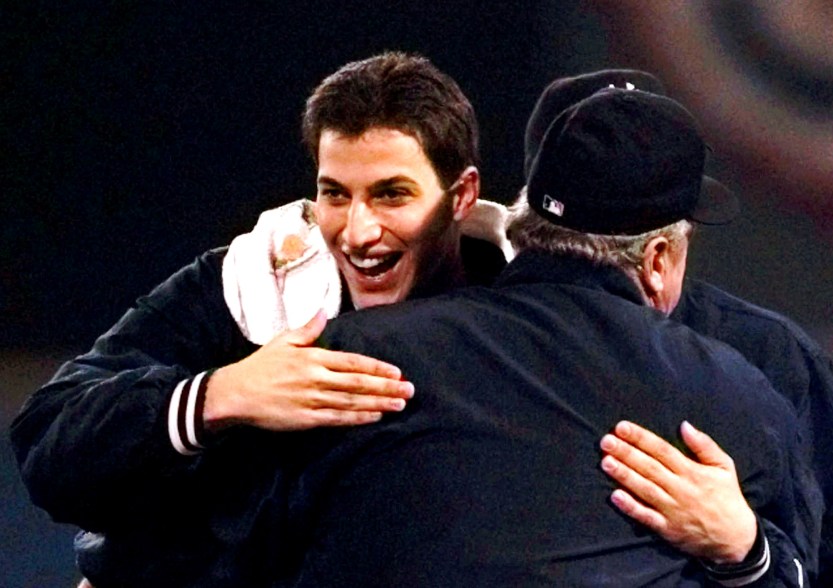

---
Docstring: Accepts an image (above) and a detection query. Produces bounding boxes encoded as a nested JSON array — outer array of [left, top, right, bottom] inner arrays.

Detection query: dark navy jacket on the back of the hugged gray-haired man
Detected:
[[288, 253, 820, 587]]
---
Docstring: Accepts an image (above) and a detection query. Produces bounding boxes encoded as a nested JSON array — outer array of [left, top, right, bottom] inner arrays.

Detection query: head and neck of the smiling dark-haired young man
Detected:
[[303, 53, 508, 308]]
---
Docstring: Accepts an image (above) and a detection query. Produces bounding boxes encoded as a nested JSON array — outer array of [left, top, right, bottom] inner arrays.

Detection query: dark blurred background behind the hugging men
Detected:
[[0, 0, 833, 587]]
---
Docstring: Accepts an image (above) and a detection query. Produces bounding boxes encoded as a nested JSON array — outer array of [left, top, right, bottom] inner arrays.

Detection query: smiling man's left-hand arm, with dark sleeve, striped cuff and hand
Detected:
[[6, 250, 412, 531]]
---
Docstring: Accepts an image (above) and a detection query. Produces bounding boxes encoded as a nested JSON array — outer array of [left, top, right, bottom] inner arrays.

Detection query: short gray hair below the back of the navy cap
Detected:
[[506, 186, 693, 289]]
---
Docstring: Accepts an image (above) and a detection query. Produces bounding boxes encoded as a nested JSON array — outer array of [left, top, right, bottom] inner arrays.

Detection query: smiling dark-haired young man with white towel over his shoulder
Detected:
[[12, 53, 509, 588]]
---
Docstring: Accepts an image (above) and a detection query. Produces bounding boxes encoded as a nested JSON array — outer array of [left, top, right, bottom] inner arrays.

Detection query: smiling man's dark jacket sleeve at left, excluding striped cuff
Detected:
[[11, 250, 253, 530]]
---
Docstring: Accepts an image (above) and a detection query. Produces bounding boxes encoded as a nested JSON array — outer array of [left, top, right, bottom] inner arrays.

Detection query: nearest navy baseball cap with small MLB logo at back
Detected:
[[527, 87, 738, 235]]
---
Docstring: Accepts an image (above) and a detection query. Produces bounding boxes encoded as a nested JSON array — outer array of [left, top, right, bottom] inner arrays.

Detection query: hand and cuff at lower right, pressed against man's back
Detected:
[[601, 422, 814, 587]]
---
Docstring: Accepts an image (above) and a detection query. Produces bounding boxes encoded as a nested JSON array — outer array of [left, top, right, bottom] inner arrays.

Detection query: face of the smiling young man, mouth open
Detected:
[[316, 128, 468, 308]]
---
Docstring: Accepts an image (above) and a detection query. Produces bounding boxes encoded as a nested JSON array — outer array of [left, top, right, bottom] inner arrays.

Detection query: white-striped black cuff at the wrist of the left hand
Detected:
[[168, 371, 211, 455]]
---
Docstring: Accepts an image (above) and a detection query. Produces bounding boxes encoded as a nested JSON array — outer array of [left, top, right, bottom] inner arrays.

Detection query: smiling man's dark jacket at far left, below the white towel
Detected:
[[11, 249, 271, 588]]
